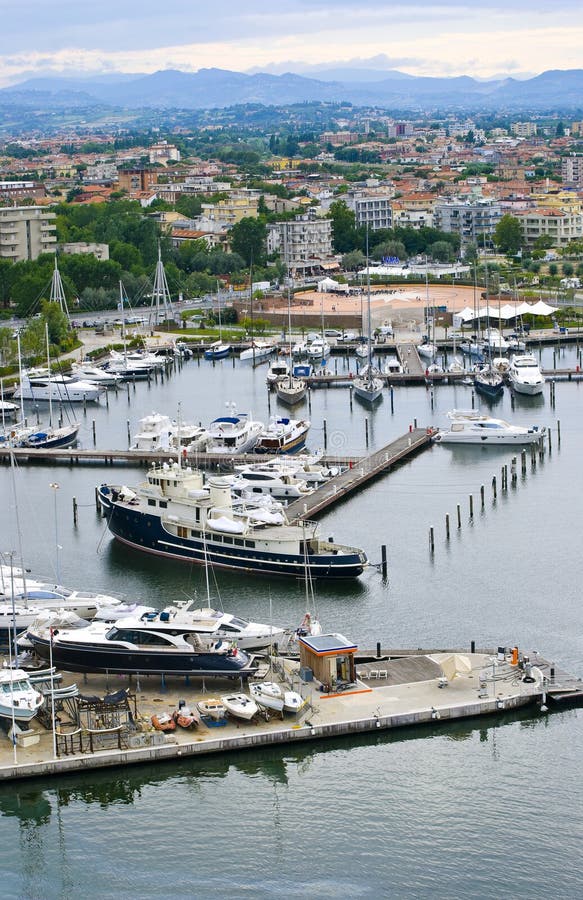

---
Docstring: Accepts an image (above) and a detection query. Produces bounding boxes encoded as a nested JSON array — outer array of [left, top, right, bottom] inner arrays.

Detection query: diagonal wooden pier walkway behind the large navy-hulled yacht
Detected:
[[287, 428, 433, 522]]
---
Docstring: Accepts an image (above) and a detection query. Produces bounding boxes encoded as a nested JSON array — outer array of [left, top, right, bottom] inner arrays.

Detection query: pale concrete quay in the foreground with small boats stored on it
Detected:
[[0, 649, 583, 781]]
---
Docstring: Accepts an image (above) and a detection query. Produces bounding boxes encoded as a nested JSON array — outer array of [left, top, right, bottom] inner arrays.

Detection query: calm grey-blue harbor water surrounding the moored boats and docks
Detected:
[[0, 347, 583, 898]]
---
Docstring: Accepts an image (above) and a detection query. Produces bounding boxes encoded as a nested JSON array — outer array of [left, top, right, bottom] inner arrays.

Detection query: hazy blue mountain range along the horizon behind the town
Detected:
[[0, 67, 583, 112]]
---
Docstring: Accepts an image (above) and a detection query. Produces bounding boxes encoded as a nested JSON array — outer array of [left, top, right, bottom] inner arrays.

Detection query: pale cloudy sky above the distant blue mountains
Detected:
[[0, 0, 583, 85]]
